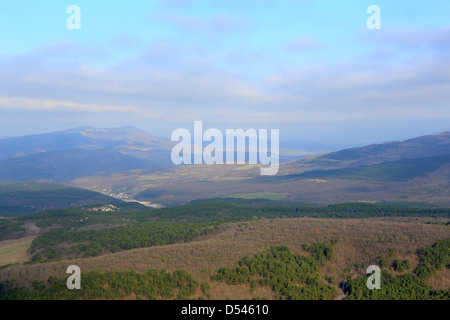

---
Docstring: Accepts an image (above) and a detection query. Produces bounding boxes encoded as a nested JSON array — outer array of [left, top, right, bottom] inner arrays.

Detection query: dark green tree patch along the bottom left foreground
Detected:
[[0, 270, 201, 300]]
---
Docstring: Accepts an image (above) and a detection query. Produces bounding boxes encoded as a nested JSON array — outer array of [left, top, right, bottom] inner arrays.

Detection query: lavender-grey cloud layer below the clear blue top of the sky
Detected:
[[0, 0, 450, 144]]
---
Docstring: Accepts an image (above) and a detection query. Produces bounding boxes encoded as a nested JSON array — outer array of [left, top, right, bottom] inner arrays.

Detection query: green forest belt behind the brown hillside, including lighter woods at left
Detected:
[[0, 199, 450, 261]]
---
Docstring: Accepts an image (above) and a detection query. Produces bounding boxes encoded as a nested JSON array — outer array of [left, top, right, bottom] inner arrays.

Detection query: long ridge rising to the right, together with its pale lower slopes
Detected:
[[70, 132, 450, 206]]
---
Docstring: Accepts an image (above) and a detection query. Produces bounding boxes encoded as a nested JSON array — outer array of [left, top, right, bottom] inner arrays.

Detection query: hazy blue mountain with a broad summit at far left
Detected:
[[0, 127, 172, 182]]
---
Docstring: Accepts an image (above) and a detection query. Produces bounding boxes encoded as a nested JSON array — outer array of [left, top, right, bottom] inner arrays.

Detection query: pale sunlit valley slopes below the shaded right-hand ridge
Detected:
[[69, 163, 450, 206]]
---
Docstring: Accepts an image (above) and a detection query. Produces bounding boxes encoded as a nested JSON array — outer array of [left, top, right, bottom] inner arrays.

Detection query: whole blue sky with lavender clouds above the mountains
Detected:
[[0, 0, 450, 148]]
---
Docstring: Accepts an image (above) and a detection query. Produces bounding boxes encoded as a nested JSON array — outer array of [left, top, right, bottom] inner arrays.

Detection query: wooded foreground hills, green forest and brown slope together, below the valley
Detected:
[[0, 201, 450, 300]]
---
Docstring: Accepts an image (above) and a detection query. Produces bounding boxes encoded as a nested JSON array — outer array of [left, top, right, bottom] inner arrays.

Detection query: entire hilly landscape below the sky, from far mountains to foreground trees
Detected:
[[0, 128, 450, 300]]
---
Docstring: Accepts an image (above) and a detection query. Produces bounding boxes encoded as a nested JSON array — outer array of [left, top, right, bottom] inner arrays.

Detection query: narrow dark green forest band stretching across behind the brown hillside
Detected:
[[4, 199, 450, 232]]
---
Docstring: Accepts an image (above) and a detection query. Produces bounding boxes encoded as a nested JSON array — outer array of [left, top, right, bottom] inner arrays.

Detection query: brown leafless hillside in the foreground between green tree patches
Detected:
[[0, 218, 450, 299]]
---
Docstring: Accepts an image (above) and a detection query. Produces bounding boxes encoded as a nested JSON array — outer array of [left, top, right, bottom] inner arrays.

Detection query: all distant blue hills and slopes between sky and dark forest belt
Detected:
[[0, 127, 450, 205]]
